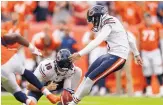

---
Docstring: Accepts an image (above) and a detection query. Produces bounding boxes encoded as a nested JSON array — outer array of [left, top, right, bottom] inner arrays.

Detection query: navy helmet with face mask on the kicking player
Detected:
[[87, 5, 108, 31]]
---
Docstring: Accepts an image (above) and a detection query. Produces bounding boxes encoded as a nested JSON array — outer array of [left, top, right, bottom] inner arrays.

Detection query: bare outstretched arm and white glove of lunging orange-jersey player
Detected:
[[3, 33, 42, 56]]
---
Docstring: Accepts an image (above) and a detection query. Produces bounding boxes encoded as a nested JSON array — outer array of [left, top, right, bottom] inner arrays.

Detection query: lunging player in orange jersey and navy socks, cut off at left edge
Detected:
[[1, 30, 59, 105]]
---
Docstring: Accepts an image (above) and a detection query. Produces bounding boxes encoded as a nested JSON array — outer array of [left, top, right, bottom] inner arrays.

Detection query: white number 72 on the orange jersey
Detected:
[[143, 30, 155, 41]]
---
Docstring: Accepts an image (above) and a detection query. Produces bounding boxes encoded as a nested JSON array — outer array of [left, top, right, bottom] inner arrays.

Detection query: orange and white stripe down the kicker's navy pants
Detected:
[[93, 58, 125, 82]]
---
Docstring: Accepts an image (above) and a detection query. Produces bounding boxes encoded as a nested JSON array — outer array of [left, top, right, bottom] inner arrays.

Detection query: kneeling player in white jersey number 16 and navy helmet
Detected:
[[27, 49, 82, 103]]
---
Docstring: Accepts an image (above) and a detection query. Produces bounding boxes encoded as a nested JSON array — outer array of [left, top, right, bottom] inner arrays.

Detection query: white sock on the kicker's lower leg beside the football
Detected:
[[73, 77, 94, 103]]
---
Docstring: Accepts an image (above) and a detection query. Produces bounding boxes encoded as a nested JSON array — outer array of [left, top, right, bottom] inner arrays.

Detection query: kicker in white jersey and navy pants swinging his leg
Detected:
[[68, 5, 142, 105]]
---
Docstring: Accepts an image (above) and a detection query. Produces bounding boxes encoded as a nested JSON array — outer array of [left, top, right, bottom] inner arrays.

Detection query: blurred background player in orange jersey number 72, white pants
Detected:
[[139, 13, 163, 96]]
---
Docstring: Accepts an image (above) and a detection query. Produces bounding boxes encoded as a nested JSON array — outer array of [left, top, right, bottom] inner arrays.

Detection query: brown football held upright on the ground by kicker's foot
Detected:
[[61, 90, 72, 105]]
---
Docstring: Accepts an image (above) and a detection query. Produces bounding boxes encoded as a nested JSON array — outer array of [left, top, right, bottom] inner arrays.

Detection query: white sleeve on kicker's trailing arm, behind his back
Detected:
[[127, 32, 140, 56]]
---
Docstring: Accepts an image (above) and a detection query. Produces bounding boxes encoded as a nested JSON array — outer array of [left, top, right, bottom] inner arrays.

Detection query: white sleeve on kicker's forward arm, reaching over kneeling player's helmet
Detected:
[[79, 24, 111, 56]]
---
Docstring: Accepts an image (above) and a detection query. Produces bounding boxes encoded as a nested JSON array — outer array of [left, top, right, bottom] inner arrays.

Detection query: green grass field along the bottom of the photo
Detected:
[[1, 95, 163, 105]]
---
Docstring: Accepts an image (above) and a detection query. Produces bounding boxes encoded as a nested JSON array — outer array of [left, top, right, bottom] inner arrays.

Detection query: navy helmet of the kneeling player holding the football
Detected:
[[56, 49, 73, 70]]
